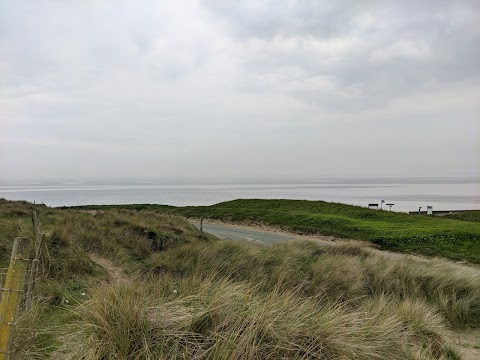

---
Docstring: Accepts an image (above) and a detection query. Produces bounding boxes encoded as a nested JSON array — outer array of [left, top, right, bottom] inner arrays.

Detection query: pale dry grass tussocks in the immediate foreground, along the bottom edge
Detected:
[[55, 275, 455, 360]]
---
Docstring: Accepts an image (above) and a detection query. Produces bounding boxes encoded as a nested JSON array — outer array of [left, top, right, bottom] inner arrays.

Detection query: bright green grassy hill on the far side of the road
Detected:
[[70, 199, 480, 263]]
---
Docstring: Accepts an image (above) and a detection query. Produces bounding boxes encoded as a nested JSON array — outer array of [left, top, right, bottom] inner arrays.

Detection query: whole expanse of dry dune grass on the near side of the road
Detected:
[[0, 200, 480, 359]]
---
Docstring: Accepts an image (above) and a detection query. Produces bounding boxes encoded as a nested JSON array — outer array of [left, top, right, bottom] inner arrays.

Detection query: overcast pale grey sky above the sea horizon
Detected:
[[0, 0, 480, 178]]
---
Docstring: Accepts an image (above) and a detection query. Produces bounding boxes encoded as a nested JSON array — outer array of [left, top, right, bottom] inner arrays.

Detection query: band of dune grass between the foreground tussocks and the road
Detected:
[[144, 242, 480, 328]]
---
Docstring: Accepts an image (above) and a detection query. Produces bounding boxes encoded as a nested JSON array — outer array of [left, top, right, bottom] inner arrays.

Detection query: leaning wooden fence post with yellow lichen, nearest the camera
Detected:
[[0, 238, 31, 360]]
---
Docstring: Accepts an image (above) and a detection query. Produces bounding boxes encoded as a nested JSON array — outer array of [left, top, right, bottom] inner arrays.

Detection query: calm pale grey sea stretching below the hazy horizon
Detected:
[[0, 177, 480, 211]]
